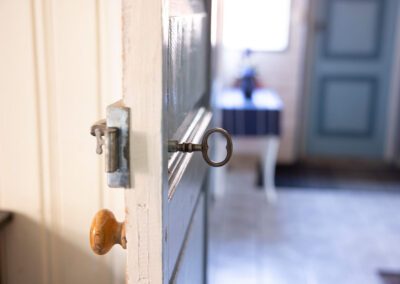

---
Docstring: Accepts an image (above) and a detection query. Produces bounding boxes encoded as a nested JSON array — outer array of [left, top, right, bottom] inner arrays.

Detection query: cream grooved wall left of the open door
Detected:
[[0, 0, 125, 284]]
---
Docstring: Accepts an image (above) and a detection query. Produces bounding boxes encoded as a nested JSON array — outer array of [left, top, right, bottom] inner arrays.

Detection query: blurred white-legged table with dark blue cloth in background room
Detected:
[[215, 88, 283, 201]]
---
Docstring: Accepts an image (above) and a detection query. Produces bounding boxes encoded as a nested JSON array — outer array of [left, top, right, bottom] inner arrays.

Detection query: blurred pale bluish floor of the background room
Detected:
[[208, 163, 400, 284]]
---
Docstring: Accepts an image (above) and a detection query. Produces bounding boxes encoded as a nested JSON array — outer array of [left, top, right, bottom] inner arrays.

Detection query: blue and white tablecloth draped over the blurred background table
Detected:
[[216, 88, 282, 136]]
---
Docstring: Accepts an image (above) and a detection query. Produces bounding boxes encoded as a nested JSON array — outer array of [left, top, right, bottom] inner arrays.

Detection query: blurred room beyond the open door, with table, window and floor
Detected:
[[209, 0, 400, 284]]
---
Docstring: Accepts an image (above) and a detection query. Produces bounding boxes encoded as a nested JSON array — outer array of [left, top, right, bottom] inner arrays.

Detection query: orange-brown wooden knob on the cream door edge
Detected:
[[90, 209, 126, 255]]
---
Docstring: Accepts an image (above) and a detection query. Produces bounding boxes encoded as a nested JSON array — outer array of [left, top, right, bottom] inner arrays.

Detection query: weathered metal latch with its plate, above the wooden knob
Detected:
[[90, 101, 130, 188]]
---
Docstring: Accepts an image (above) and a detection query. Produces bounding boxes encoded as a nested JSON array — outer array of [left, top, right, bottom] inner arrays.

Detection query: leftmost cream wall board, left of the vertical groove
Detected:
[[0, 1, 47, 283]]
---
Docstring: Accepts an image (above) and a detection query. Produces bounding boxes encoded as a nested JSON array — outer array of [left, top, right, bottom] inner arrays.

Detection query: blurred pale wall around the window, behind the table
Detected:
[[217, 0, 309, 163]]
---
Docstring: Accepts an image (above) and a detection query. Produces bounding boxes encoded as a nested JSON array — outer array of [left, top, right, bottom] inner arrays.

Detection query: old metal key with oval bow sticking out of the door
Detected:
[[168, 128, 233, 167]]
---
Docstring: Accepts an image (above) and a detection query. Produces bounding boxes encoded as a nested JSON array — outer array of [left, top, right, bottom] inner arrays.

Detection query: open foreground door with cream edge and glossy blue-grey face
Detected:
[[122, 0, 211, 284]]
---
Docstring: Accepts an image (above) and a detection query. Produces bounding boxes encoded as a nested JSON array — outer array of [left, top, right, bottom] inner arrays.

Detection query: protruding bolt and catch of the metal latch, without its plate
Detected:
[[90, 119, 118, 173]]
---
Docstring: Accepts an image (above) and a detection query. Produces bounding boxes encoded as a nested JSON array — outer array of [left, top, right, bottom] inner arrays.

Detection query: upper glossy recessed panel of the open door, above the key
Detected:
[[167, 13, 207, 139]]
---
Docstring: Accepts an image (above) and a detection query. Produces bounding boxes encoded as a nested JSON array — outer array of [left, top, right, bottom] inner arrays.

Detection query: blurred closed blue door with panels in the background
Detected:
[[306, 0, 398, 159]]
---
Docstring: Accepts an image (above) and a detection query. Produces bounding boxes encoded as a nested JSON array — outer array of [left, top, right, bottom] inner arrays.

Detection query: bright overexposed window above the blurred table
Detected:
[[223, 0, 291, 51]]
